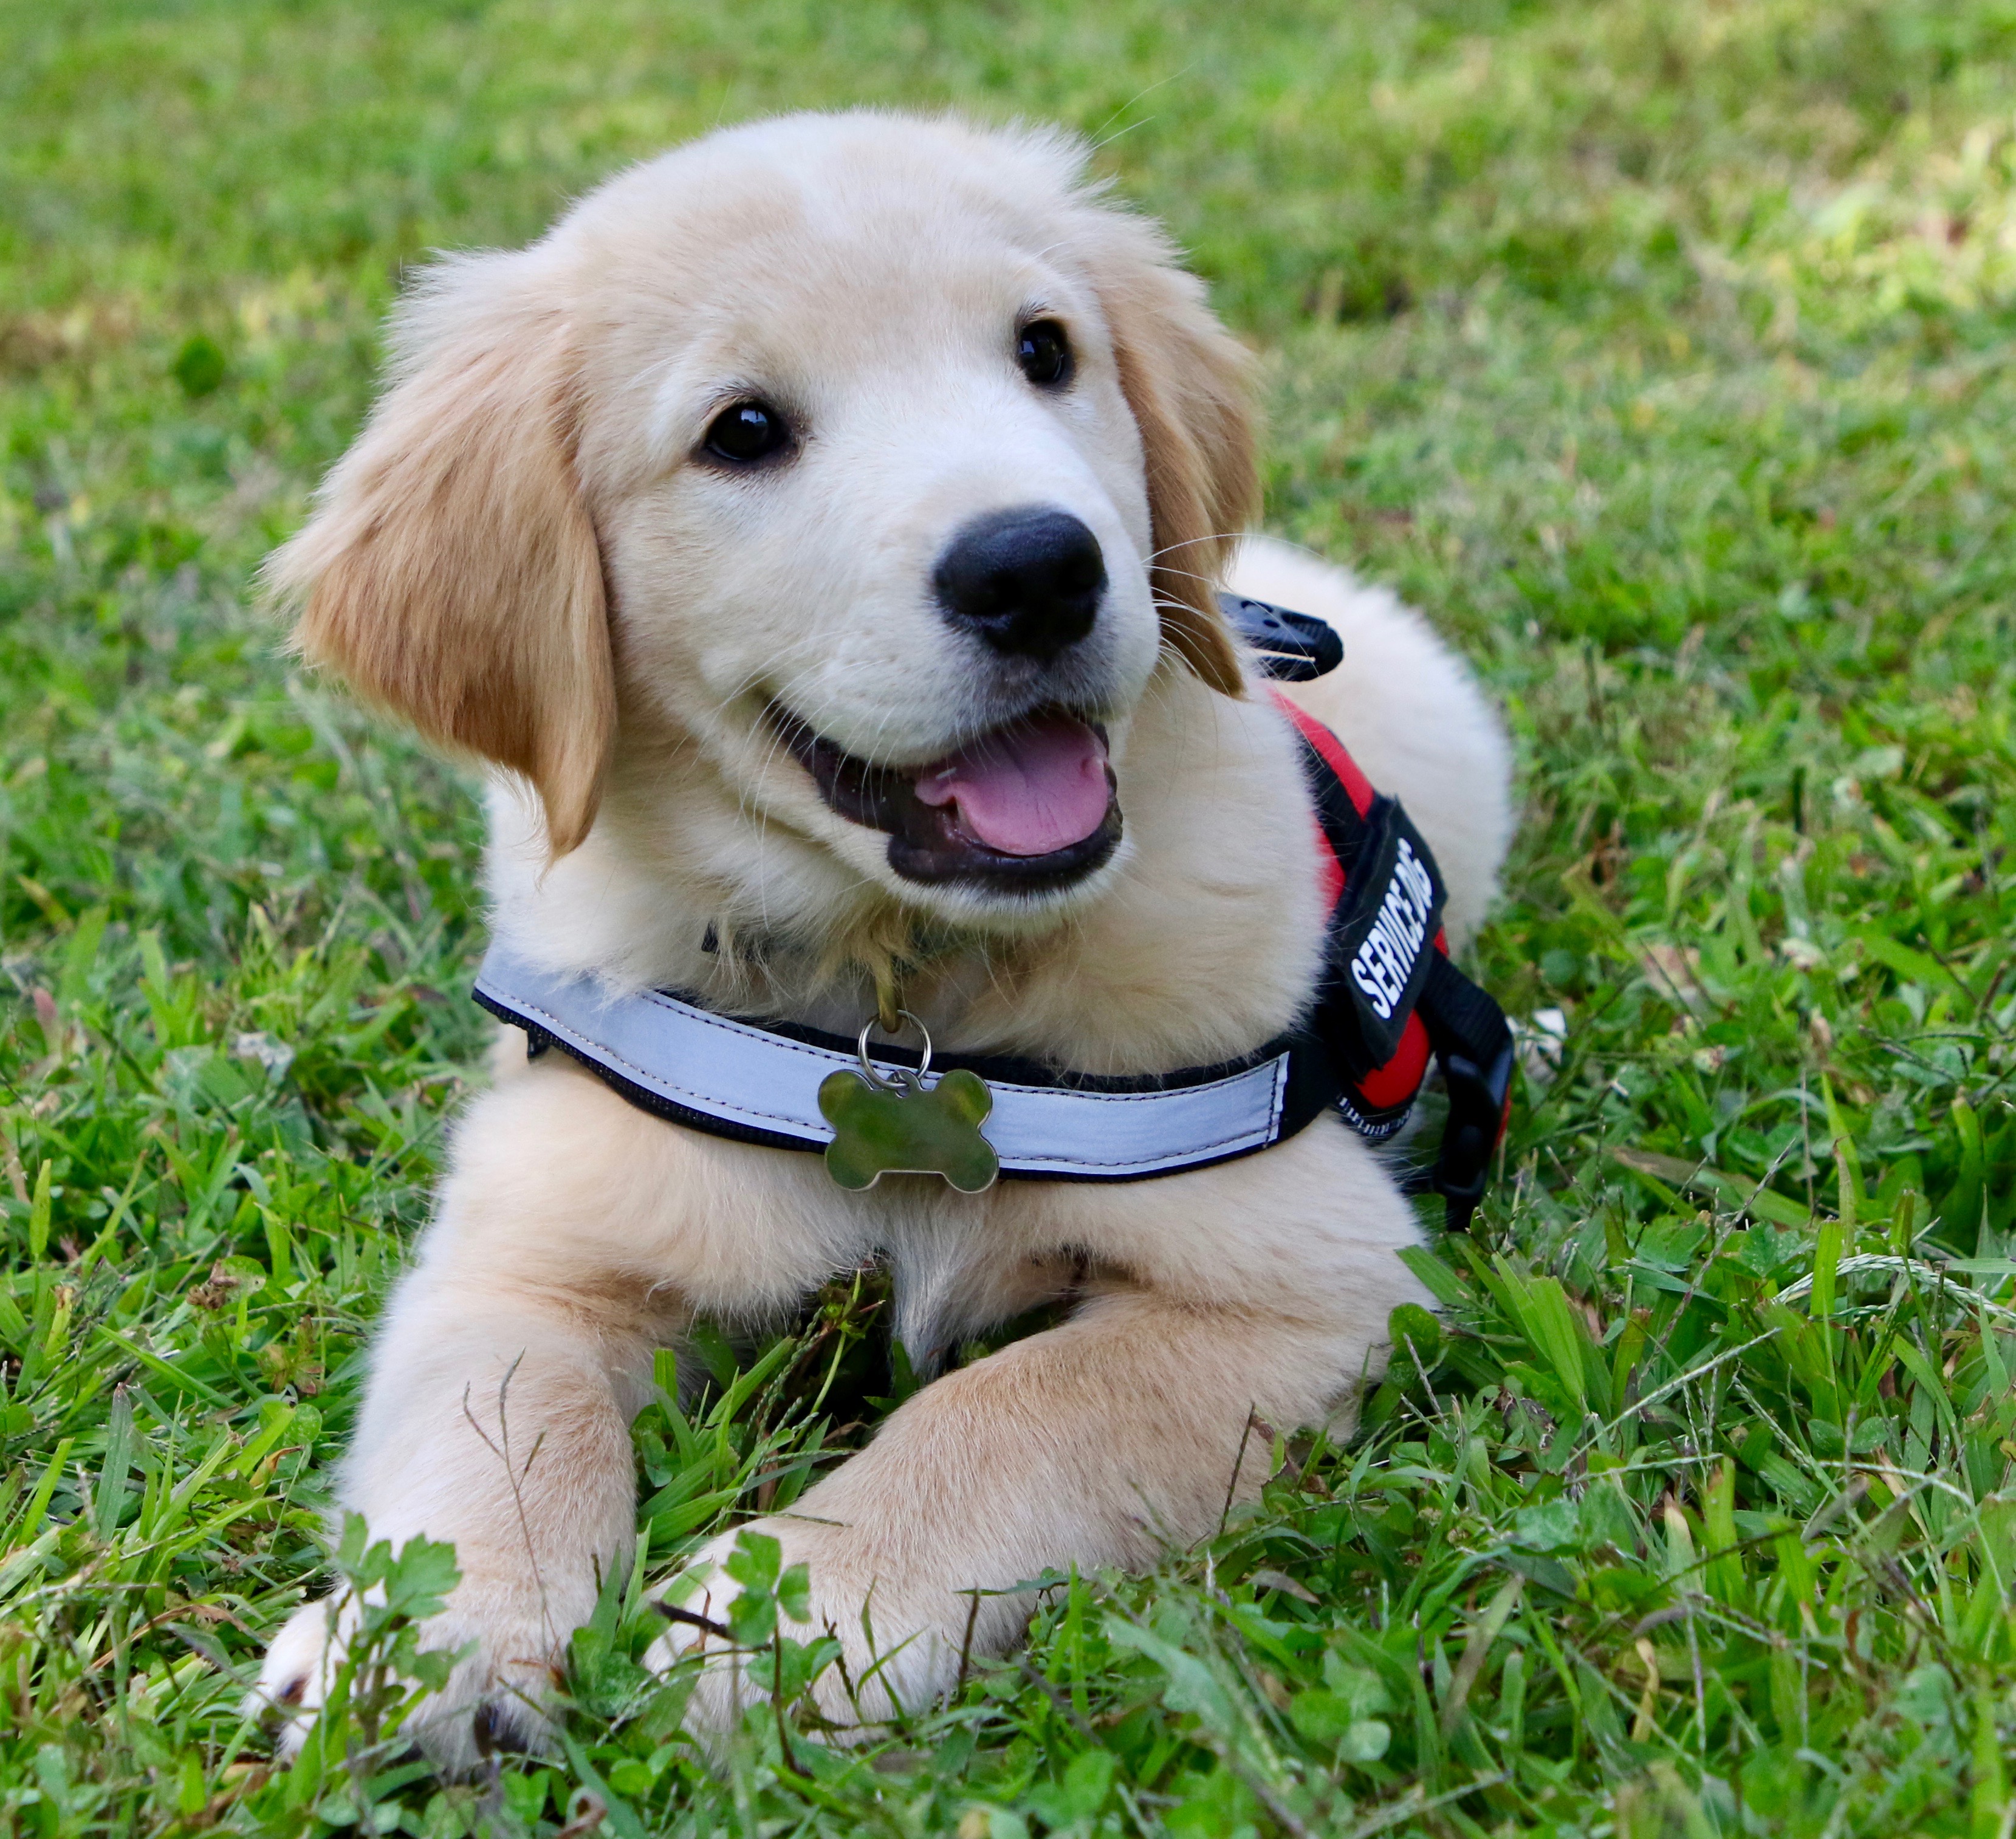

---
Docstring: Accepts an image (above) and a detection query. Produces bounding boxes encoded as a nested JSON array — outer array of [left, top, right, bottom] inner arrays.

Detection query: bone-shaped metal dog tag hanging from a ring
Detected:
[[818, 1008, 1000, 1194]]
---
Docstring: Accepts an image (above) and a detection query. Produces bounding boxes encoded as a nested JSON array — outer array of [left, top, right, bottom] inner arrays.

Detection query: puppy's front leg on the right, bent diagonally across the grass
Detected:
[[651, 1279, 1411, 1730]]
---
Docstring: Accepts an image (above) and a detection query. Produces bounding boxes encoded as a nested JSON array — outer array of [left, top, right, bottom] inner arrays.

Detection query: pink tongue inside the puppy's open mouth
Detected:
[[917, 716, 1109, 855]]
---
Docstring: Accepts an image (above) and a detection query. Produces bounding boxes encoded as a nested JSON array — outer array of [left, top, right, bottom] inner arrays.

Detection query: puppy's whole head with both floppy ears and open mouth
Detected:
[[270, 115, 1256, 924]]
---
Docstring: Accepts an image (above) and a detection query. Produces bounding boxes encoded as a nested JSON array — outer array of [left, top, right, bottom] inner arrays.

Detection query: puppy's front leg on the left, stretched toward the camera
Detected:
[[260, 1057, 859, 1769]]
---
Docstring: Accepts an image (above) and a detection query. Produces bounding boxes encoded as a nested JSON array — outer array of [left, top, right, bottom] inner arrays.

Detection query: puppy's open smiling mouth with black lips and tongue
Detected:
[[772, 706, 1121, 893]]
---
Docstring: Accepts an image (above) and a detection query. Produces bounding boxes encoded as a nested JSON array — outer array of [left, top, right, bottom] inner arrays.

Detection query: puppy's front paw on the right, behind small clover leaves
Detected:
[[645, 1514, 965, 1736]]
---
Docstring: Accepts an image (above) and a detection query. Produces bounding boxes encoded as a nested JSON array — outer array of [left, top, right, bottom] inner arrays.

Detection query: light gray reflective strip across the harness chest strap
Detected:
[[476, 947, 1288, 1175]]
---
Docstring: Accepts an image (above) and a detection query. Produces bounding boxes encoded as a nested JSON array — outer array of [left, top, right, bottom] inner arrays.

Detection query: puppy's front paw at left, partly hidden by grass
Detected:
[[252, 1587, 558, 1775]]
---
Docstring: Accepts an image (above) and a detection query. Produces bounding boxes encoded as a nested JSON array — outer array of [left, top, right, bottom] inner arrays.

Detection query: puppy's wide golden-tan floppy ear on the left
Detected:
[[266, 250, 615, 857]]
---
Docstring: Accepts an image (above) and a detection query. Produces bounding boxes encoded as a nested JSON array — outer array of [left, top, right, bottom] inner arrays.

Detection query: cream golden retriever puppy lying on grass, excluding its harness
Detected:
[[262, 113, 1510, 1764]]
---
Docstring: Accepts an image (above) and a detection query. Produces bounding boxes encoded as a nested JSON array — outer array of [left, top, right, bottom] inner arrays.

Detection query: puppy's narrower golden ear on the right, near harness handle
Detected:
[[1091, 211, 1260, 696]]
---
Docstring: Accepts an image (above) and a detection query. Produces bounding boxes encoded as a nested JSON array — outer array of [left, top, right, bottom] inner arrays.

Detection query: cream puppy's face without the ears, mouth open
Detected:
[[581, 132, 1161, 901]]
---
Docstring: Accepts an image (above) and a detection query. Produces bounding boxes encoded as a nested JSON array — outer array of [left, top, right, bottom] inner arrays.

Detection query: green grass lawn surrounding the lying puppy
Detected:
[[0, 0, 2016, 1839]]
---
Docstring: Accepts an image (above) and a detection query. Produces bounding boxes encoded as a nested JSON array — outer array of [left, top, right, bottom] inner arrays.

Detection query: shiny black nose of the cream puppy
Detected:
[[931, 508, 1107, 664]]
